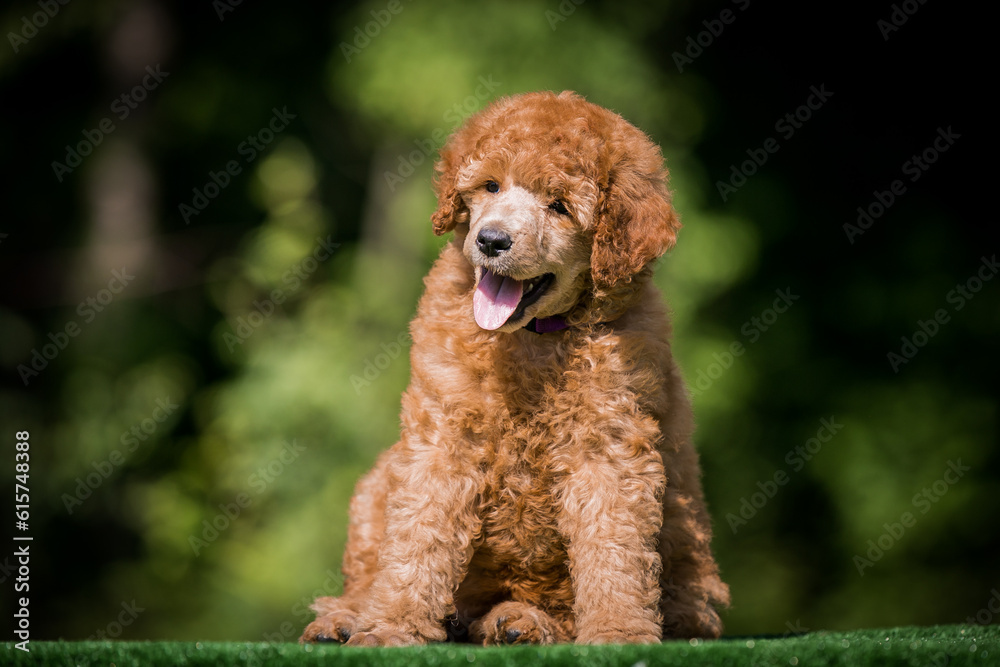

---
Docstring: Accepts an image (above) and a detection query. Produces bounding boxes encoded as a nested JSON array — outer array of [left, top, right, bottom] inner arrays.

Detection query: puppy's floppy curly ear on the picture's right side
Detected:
[[590, 150, 681, 287]]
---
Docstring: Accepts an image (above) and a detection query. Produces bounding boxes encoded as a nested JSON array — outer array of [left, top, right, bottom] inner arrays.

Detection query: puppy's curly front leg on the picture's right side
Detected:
[[560, 450, 663, 644]]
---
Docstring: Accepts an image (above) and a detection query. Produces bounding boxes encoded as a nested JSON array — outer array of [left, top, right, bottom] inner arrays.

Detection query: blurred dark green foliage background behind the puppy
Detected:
[[0, 0, 1000, 640]]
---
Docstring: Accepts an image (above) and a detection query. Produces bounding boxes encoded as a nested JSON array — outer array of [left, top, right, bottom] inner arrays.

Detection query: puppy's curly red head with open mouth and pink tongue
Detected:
[[432, 92, 680, 331]]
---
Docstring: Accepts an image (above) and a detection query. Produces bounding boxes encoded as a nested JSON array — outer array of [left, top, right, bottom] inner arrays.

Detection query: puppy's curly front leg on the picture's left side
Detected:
[[348, 443, 480, 646]]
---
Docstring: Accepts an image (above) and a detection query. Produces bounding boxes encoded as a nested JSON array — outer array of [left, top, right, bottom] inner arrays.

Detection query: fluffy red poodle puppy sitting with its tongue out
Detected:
[[302, 92, 729, 646]]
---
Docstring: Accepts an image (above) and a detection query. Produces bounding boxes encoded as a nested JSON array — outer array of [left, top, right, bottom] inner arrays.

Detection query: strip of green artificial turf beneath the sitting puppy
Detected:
[[0, 625, 1000, 667]]
